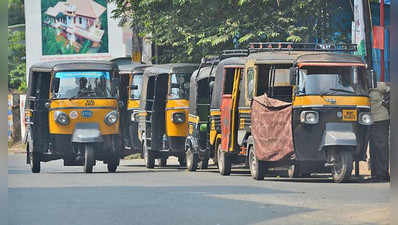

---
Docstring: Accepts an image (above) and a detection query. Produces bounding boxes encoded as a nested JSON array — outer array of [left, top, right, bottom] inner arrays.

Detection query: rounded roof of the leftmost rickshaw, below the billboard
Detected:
[[30, 60, 118, 72]]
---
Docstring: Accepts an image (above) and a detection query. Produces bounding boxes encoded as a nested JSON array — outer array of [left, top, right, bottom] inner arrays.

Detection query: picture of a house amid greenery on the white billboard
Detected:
[[41, 0, 109, 56]]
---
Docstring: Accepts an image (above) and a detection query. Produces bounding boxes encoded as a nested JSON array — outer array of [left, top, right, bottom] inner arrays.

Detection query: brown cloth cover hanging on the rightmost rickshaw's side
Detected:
[[251, 94, 293, 161]]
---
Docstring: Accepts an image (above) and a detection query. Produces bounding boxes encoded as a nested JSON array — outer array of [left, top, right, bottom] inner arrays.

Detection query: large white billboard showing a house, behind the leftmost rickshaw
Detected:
[[24, 0, 145, 77]]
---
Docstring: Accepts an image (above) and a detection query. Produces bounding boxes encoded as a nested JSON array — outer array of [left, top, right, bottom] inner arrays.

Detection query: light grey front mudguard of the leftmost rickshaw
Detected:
[[72, 123, 104, 143]]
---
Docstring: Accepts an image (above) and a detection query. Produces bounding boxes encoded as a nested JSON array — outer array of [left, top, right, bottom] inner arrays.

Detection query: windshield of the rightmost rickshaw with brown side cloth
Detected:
[[297, 67, 368, 96]]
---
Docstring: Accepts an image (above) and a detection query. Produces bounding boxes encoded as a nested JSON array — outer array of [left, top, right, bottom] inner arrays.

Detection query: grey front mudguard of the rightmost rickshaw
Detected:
[[319, 123, 358, 150]]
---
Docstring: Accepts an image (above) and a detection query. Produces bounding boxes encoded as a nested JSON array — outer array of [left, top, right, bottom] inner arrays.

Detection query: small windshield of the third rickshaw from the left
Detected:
[[169, 73, 190, 100]]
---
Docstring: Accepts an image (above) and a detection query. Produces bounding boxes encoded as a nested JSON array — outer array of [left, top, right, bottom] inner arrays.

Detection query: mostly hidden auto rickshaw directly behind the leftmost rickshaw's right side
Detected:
[[119, 63, 150, 156]]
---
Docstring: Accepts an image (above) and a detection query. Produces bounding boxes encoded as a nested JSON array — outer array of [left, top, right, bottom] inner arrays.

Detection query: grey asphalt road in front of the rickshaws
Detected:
[[8, 154, 390, 225]]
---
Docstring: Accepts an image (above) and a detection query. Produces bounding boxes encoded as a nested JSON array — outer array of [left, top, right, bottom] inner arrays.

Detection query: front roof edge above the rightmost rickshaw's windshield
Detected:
[[296, 53, 365, 64]]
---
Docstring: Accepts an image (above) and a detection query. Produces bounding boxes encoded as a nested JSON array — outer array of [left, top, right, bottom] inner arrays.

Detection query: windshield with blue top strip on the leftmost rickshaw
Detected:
[[51, 71, 115, 99]]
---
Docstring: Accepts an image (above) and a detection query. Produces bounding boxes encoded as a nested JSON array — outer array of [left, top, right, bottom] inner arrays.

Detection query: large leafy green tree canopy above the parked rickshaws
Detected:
[[109, 0, 349, 62]]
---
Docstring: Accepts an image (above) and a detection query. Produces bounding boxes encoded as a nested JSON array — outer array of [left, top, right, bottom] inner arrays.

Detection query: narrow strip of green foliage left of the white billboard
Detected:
[[8, 31, 26, 91]]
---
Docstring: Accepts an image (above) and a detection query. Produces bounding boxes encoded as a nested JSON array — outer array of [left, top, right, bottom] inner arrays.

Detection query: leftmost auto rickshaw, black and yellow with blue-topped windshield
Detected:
[[25, 61, 121, 173]]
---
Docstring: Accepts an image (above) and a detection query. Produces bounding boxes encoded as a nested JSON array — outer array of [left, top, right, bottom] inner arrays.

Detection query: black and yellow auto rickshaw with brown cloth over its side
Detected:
[[222, 43, 371, 182]]
